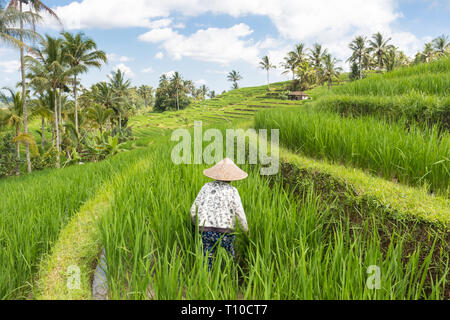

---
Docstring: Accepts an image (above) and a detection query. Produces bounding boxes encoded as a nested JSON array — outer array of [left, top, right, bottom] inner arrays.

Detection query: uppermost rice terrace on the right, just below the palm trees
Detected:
[[317, 57, 450, 130]]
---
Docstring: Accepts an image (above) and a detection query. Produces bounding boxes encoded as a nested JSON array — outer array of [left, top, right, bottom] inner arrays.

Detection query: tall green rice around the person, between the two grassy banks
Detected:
[[100, 138, 448, 299]]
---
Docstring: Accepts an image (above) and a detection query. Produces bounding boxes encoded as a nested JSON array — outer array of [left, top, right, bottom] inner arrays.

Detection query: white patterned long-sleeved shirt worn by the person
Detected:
[[191, 181, 248, 233]]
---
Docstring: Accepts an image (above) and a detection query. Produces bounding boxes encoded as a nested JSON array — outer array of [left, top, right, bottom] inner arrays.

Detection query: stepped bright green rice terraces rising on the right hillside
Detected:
[[257, 58, 450, 196]]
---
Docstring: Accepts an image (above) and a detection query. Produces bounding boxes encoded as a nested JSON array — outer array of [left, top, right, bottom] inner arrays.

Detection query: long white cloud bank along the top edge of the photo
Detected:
[[50, 0, 398, 40]]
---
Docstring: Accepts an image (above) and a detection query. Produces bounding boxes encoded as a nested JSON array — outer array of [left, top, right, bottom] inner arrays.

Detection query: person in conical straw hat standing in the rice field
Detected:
[[191, 158, 249, 270]]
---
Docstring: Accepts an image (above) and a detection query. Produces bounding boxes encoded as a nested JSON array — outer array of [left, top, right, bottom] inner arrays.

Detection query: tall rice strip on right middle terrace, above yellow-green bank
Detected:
[[255, 108, 450, 195]]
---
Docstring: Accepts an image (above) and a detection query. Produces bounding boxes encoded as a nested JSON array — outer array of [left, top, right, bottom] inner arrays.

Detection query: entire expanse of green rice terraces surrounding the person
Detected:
[[0, 65, 450, 300]]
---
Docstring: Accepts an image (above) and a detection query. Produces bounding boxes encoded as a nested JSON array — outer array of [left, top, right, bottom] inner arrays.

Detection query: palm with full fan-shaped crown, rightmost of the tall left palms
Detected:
[[62, 32, 107, 133]]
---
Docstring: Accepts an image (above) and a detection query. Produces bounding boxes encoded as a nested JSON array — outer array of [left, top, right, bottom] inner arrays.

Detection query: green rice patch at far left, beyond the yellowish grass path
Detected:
[[0, 146, 152, 299]]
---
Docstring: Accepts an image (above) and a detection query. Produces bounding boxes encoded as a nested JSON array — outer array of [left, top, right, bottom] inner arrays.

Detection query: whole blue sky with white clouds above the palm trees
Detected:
[[0, 0, 450, 93]]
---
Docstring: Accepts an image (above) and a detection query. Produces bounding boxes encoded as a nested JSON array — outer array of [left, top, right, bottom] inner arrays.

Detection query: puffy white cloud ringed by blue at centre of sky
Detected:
[[139, 23, 259, 64]]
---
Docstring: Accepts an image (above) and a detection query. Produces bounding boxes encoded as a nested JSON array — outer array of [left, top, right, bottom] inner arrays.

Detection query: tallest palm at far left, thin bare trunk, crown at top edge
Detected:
[[9, 0, 61, 172]]
